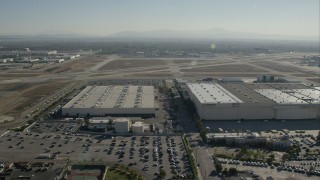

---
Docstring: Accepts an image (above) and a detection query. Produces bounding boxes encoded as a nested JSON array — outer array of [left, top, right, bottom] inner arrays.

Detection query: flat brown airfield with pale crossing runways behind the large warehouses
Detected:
[[0, 52, 320, 132]]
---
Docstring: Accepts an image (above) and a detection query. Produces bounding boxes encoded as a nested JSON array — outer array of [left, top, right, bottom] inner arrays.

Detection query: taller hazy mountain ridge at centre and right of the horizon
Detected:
[[108, 29, 319, 41]]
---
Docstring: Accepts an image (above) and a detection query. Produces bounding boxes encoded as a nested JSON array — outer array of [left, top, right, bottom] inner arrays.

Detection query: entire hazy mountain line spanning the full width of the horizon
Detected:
[[0, 28, 319, 42]]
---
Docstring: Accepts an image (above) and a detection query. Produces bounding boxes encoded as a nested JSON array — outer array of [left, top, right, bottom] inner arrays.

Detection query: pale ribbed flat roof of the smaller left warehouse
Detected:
[[64, 86, 154, 108]]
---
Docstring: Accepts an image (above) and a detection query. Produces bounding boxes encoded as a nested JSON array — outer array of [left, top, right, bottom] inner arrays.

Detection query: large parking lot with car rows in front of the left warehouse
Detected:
[[0, 131, 192, 179]]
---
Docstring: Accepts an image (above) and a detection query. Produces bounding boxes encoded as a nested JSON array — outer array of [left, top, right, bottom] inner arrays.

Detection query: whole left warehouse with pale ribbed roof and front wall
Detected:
[[62, 85, 155, 117]]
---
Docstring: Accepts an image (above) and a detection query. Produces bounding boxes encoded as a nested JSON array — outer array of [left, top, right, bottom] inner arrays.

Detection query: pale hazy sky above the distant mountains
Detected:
[[0, 0, 319, 36]]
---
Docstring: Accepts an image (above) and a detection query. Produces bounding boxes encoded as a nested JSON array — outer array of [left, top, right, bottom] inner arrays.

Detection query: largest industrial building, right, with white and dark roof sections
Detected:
[[186, 83, 320, 120]]
